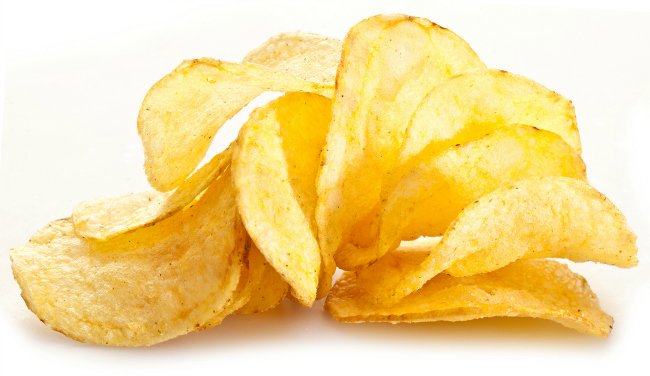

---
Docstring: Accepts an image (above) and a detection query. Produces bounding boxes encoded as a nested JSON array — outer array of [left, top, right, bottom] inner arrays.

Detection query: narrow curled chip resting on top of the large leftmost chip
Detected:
[[72, 148, 231, 240]]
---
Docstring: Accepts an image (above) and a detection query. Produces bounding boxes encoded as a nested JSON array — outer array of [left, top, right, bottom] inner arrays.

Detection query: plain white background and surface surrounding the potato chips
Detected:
[[0, 0, 650, 375]]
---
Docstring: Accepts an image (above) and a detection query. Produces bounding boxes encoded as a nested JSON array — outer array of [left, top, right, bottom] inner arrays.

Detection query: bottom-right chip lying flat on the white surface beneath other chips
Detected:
[[325, 250, 614, 337]]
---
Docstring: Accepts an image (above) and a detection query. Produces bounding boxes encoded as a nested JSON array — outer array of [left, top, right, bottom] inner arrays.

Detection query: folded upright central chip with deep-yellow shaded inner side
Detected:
[[233, 93, 331, 306]]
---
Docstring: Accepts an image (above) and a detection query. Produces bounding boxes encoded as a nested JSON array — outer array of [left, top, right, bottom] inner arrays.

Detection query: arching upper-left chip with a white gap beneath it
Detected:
[[138, 58, 333, 191]]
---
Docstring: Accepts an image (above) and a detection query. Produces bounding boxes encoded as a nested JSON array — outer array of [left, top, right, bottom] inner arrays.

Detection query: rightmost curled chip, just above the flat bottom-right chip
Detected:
[[359, 177, 637, 304]]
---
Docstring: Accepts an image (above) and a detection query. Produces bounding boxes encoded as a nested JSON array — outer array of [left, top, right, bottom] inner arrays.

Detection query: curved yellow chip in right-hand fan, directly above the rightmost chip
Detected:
[[336, 125, 585, 270]]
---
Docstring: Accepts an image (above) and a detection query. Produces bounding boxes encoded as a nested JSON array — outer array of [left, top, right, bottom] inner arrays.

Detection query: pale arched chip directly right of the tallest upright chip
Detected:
[[399, 69, 580, 164]]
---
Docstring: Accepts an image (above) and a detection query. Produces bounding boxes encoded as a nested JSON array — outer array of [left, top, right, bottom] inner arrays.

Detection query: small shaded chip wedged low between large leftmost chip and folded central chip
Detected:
[[237, 242, 289, 314]]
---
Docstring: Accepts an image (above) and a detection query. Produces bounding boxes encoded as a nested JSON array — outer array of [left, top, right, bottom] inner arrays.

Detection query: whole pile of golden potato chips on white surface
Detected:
[[11, 15, 637, 346]]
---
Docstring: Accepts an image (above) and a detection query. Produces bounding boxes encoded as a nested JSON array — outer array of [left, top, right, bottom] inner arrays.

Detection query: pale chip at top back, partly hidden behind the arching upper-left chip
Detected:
[[243, 33, 341, 87]]
